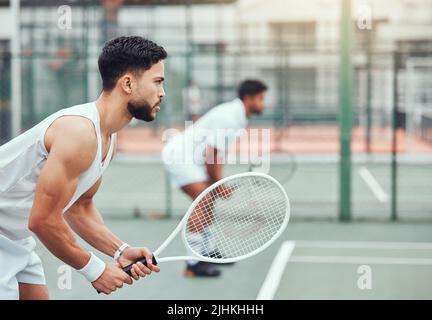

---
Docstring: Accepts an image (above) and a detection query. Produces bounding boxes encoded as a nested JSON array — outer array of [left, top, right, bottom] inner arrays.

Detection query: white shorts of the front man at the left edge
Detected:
[[0, 235, 46, 300]]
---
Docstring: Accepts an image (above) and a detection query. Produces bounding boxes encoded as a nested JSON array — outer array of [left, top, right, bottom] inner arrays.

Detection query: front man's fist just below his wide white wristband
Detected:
[[92, 263, 132, 294]]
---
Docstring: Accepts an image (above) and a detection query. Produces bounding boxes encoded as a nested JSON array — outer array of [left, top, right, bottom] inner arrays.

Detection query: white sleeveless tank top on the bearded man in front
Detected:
[[0, 102, 115, 240]]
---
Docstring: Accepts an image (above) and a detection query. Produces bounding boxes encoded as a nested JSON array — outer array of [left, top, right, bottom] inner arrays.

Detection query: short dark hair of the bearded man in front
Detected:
[[98, 36, 167, 91]]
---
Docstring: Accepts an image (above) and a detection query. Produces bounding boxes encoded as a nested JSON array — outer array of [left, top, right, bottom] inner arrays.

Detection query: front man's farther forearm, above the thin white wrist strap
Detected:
[[65, 202, 123, 257]]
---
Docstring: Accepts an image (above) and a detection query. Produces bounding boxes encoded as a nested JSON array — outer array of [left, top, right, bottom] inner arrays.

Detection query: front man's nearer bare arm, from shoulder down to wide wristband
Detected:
[[29, 118, 97, 269]]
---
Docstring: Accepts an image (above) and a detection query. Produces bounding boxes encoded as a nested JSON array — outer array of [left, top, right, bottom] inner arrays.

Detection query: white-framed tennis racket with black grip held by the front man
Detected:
[[123, 172, 290, 275]]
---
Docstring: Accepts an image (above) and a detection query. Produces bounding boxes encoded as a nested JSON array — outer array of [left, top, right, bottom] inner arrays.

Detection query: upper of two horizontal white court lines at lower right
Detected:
[[295, 240, 432, 250]]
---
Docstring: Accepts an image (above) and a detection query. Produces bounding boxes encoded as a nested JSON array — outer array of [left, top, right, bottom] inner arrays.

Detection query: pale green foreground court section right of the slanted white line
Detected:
[[268, 241, 432, 299]]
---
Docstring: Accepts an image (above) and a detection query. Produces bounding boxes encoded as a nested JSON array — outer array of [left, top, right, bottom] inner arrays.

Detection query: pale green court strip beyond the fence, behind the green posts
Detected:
[[96, 155, 432, 221]]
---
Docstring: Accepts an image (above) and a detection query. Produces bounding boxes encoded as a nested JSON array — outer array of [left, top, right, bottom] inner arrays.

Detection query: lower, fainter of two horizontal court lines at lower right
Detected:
[[290, 256, 432, 266]]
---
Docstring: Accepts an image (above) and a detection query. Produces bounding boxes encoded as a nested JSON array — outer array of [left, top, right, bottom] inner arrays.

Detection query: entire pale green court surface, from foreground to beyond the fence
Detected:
[[38, 155, 432, 300]]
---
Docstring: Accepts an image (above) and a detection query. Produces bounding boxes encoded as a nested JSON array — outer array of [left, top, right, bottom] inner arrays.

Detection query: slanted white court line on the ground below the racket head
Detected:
[[257, 241, 295, 300]]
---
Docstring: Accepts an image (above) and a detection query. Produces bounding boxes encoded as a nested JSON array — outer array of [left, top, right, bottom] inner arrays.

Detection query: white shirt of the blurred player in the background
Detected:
[[162, 99, 247, 165]]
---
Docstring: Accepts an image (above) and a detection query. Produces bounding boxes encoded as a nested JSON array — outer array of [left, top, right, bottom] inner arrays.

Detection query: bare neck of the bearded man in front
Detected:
[[96, 92, 132, 137]]
